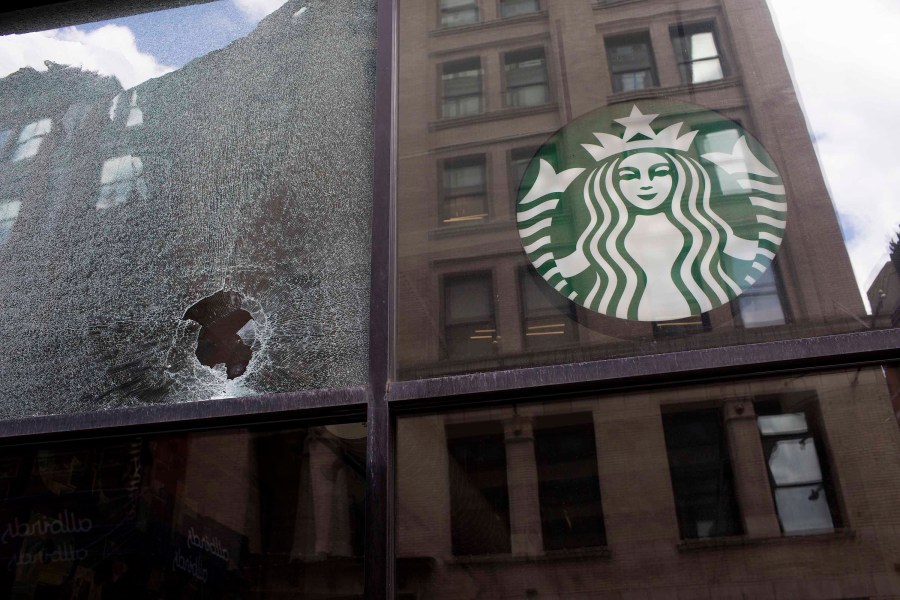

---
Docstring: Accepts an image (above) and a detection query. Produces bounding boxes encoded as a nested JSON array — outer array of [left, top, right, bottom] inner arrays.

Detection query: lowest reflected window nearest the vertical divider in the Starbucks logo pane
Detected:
[[444, 273, 497, 358]]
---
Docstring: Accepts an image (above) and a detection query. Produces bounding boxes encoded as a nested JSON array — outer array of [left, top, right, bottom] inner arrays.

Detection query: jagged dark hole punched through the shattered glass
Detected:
[[183, 290, 256, 379]]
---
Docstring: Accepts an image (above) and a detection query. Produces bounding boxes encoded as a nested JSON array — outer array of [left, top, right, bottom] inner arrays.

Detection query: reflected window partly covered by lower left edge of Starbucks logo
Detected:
[[519, 266, 578, 350]]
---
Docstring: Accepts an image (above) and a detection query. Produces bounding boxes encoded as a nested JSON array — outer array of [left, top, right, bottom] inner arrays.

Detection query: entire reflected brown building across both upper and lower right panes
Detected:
[[397, 0, 900, 599]]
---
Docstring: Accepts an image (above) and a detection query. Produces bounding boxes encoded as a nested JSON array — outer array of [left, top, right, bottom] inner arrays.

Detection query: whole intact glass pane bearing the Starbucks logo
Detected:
[[396, 0, 900, 379]]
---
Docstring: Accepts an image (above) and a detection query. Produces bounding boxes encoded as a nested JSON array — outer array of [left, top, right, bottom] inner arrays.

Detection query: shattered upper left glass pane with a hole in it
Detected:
[[0, 0, 375, 417]]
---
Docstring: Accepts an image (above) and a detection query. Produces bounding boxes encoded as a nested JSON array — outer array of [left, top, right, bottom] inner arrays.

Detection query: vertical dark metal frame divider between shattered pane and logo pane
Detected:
[[365, 0, 397, 600]]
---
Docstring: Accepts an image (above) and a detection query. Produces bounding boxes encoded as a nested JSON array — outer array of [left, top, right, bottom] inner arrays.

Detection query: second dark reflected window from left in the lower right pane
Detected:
[[534, 413, 606, 550]]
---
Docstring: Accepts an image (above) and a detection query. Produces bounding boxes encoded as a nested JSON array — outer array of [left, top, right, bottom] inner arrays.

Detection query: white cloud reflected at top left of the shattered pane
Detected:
[[0, 25, 174, 89]]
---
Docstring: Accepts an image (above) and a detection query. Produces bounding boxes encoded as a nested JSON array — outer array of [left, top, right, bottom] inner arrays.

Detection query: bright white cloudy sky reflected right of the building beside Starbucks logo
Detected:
[[769, 0, 900, 302]]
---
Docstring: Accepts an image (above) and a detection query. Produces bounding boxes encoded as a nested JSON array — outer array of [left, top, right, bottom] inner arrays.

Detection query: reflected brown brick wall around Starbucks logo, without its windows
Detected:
[[397, 0, 865, 378]]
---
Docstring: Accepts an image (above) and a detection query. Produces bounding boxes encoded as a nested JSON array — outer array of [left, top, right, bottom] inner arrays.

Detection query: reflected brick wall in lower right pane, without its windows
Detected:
[[397, 369, 900, 599]]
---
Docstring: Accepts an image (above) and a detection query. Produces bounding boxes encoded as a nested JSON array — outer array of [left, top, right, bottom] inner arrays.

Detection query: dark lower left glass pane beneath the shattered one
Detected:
[[0, 423, 366, 600]]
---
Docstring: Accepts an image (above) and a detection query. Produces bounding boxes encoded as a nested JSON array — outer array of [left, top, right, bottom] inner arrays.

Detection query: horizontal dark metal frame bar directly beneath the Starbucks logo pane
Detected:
[[388, 329, 900, 412]]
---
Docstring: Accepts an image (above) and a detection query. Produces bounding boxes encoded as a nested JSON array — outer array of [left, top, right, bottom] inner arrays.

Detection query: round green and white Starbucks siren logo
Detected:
[[517, 100, 787, 321]]
